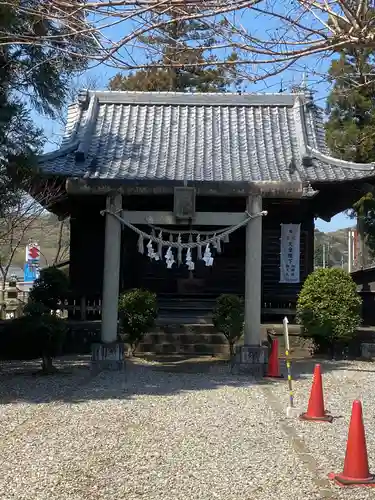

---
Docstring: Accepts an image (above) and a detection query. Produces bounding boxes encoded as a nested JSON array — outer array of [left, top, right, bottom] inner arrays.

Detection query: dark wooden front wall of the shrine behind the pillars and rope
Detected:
[[70, 196, 314, 303]]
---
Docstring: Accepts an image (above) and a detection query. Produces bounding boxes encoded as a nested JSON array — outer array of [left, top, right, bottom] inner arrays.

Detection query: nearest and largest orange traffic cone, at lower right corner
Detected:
[[328, 401, 375, 487]]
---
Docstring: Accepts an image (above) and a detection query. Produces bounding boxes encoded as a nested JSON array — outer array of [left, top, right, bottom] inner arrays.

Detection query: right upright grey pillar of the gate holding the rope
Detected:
[[244, 195, 262, 346]]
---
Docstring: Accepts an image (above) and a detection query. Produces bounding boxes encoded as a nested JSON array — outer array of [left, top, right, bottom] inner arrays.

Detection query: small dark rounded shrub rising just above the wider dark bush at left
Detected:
[[29, 267, 69, 311]]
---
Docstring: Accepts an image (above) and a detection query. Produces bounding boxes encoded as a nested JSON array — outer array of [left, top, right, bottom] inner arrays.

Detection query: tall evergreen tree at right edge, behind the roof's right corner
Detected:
[[326, 45, 375, 254]]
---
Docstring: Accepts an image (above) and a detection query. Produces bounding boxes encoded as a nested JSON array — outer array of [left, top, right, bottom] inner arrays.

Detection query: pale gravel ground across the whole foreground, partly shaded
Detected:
[[0, 361, 375, 500]]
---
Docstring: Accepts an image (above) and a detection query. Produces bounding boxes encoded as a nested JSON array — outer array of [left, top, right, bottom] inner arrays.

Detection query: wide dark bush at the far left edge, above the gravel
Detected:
[[2, 303, 67, 373]]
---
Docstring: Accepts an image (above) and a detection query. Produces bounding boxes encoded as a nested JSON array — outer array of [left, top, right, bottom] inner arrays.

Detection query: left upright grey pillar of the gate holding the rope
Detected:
[[101, 193, 122, 343]]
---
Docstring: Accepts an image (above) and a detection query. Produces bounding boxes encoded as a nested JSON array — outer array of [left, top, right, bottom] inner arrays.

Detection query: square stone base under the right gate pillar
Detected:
[[232, 345, 268, 377]]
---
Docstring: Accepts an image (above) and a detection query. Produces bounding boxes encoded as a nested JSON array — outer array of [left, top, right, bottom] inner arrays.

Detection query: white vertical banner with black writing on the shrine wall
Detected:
[[280, 224, 301, 283]]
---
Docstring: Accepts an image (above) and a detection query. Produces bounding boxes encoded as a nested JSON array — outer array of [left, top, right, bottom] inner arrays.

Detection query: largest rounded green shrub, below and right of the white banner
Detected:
[[297, 268, 362, 357]]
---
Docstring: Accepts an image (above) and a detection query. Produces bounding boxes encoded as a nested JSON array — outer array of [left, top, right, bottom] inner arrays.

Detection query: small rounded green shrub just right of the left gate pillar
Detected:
[[119, 289, 158, 355]]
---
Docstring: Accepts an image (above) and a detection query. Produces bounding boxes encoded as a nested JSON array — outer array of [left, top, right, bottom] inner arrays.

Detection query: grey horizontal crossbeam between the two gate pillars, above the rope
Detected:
[[122, 210, 247, 226]]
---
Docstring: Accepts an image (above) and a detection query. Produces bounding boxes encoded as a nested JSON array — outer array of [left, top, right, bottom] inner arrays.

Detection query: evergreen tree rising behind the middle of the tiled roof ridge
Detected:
[[109, 12, 241, 92]]
